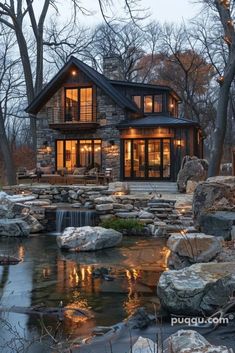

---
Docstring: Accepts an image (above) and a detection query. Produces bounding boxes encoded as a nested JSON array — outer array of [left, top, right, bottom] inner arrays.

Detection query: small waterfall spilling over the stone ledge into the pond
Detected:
[[56, 209, 97, 233]]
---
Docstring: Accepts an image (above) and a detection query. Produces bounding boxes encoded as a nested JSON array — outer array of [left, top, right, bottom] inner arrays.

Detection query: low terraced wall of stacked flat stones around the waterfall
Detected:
[[4, 185, 192, 236]]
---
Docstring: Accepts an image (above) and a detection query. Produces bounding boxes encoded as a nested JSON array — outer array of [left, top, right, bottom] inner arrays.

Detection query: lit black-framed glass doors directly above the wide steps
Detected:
[[123, 138, 171, 180]]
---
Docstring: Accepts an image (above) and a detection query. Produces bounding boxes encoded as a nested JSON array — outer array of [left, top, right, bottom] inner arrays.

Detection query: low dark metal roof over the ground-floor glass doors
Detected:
[[118, 115, 198, 129]]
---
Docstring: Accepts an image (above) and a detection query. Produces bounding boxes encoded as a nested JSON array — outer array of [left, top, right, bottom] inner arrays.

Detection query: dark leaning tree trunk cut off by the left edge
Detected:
[[0, 106, 16, 185]]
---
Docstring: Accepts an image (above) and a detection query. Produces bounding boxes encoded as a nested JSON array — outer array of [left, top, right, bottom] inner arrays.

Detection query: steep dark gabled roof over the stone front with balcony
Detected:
[[25, 56, 139, 114]]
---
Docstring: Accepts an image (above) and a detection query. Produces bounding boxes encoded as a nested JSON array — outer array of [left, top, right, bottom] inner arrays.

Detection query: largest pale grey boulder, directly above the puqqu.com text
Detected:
[[157, 262, 235, 315]]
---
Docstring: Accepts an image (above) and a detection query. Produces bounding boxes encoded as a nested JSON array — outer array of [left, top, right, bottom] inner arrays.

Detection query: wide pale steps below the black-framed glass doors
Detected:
[[126, 181, 178, 194]]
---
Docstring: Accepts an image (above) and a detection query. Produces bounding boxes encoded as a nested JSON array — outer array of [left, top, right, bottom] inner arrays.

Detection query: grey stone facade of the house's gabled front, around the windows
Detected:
[[37, 88, 126, 180]]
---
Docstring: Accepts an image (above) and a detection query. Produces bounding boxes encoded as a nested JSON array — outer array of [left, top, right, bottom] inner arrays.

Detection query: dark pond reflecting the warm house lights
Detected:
[[0, 235, 168, 353]]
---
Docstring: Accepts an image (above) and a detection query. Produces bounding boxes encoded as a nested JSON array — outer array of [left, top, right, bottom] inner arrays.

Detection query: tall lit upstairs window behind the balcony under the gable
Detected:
[[65, 87, 93, 122]]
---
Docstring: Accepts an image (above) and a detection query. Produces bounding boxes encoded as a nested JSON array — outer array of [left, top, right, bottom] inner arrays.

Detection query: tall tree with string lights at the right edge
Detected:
[[198, 0, 235, 176]]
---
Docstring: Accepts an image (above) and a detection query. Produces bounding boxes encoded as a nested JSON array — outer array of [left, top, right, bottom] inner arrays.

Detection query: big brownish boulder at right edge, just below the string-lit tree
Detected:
[[193, 177, 235, 226]]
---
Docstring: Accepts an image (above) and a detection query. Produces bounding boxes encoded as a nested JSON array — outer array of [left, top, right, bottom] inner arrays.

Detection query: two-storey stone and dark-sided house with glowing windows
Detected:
[[26, 56, 202, 181]]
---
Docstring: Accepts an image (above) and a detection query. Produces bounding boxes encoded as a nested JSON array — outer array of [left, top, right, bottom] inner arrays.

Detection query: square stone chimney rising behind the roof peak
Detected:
[[103, 54, 125, 81]]
